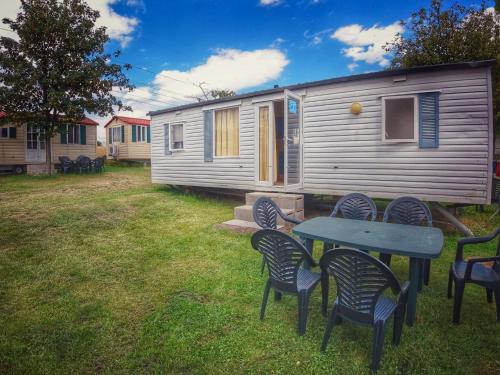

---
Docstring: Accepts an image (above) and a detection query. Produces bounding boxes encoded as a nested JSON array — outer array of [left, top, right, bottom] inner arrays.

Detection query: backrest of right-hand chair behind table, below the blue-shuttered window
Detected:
[[383, 197, 432, 227]]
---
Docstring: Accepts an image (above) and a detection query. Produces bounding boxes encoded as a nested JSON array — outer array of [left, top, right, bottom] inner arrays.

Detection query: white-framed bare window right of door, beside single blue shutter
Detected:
[[382, 96, 418, 142]]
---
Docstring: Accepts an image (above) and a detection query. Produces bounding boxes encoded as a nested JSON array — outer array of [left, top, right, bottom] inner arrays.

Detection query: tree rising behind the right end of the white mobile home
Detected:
[[386, 0, 500, 126]]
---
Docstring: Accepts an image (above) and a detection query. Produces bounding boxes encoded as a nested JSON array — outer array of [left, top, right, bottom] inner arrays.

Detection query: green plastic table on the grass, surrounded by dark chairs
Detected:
[[293, 217, 444, 326]]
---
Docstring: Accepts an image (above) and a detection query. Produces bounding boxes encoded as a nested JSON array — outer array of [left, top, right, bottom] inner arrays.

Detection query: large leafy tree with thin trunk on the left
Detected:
[[0, 0, 133, 174]]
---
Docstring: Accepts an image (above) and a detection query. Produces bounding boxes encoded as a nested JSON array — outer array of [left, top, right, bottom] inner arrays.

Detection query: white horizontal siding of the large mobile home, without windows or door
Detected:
[[152, 68, 493, 203]]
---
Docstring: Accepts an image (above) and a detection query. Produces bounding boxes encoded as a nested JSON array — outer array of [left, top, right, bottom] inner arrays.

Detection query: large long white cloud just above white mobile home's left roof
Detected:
[[108, 48, 289, 122]]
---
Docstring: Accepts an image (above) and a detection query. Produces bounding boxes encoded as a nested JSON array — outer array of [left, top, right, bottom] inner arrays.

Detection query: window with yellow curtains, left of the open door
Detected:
[[214, 107, 240, 156]]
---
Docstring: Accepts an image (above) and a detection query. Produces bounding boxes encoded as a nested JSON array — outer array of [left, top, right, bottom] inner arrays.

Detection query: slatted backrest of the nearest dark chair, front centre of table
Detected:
[[320, 249, 401, 324]]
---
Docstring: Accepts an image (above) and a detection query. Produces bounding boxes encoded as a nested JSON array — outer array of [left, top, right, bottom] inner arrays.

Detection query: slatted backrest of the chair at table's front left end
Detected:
[[252, 229, 312, 292]]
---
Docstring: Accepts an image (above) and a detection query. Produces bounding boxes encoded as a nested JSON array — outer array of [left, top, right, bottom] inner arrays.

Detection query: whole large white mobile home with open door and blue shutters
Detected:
[[150, 61, 494, 203]]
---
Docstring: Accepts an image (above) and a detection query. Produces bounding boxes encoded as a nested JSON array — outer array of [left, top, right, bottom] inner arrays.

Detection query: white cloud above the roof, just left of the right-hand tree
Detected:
[[330, 22, 404, 66]]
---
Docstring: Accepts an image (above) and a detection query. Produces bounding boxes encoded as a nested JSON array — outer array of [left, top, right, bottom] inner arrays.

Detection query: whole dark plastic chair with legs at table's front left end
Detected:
[[252, 229, 320, 335]]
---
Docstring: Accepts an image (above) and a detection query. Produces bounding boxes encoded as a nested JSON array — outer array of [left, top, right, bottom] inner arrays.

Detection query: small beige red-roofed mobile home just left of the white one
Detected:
[[104, 116, 151, 161]]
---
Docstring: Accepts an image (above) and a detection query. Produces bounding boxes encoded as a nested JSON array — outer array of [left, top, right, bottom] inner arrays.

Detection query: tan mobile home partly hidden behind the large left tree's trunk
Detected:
[[0, 113, 99, 174]]
